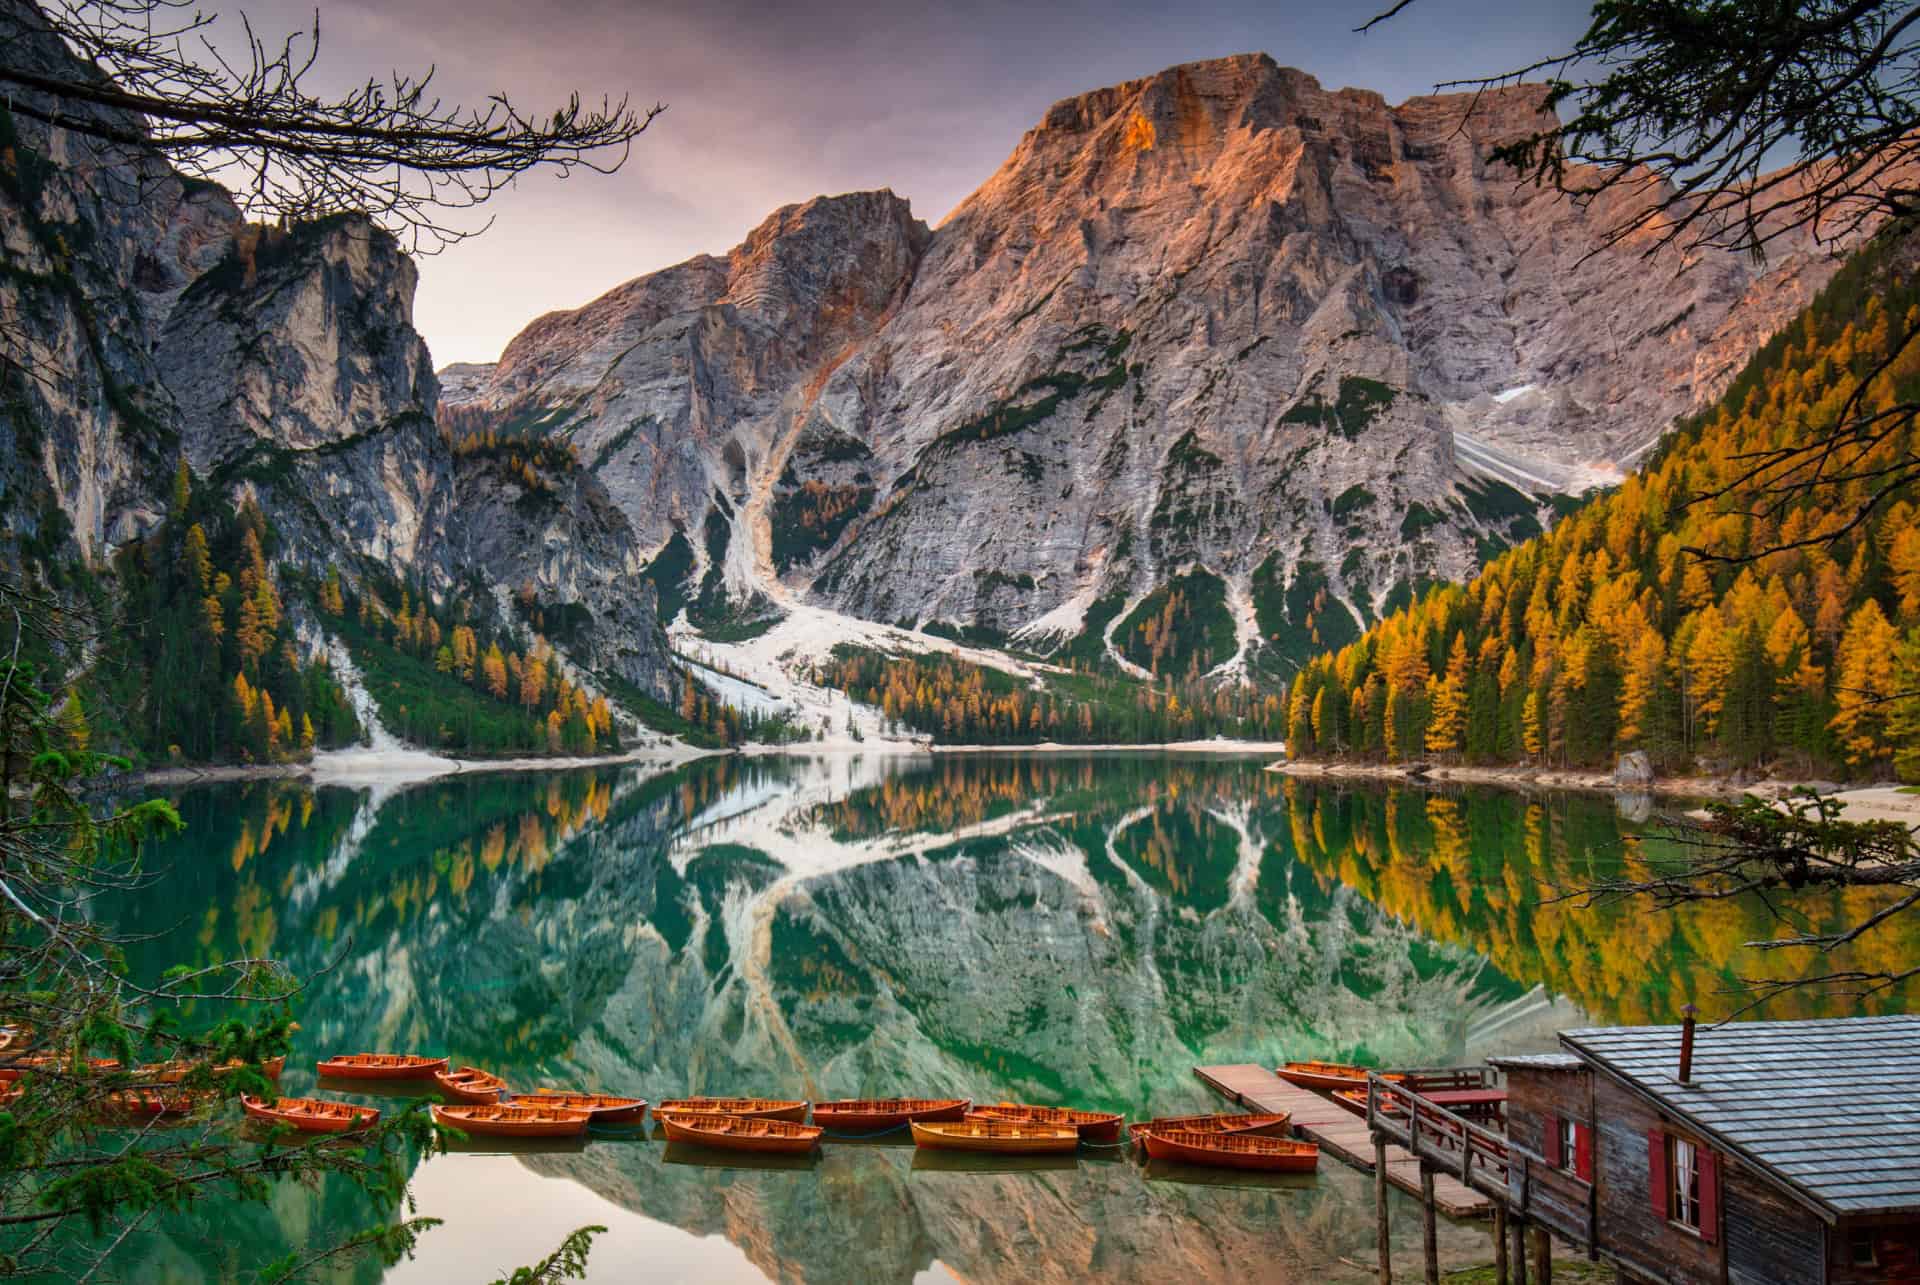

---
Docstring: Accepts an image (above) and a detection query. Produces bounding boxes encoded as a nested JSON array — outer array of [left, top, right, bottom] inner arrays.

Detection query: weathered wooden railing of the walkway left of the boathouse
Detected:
[[1367, 1072, 1596, 1247]]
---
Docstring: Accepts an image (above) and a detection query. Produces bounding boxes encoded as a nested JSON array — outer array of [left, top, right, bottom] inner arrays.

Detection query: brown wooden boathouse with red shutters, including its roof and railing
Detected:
[[1369, 1016, 1920, 1285]]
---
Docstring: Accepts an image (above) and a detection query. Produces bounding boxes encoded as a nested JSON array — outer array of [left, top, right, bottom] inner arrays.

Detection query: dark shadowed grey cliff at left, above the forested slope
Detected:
[[0, 4, 668, 693]]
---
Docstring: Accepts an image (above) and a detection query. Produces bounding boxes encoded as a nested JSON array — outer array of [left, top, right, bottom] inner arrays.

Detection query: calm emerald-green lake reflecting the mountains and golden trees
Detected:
[[86, 753, 1912, 1283]]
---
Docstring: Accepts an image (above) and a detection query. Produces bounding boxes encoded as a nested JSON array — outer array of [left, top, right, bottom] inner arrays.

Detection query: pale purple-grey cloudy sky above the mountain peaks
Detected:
[[224, 0, 1588, 365]]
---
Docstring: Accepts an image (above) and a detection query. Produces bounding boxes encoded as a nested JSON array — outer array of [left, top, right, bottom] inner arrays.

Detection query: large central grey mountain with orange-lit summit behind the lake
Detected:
[[445, 56, 1858, 672]]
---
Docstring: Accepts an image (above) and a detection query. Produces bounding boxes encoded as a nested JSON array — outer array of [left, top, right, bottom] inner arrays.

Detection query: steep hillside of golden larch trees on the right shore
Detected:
[[1286, 229, 1920, 780]]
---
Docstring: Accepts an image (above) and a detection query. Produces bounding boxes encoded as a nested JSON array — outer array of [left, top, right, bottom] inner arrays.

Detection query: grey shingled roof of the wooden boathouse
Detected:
[[1561, 1016, 1920, 1222]]
